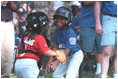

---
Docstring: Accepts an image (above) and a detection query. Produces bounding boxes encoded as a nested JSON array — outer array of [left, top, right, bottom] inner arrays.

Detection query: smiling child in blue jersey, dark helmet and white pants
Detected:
[[47, 7, 83, 78]]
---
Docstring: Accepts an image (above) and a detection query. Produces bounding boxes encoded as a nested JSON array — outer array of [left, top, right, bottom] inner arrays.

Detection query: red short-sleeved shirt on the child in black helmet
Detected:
[[16, 35, 50, 62]]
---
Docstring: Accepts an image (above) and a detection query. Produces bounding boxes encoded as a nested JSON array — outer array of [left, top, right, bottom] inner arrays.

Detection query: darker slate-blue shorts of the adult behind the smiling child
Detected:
[[80, 27, 102, 53]]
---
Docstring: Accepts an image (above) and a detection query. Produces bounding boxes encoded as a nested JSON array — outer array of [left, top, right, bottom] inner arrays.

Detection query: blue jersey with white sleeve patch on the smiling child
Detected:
[[53, 27, 80, 56]]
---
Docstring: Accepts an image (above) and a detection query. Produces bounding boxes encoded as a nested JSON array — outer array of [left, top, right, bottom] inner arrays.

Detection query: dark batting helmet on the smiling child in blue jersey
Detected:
[[53, 7, 72, 26]]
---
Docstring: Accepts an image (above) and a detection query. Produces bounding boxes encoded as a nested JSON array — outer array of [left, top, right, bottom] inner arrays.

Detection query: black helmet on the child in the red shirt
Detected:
[[26, 12, 49, 34]]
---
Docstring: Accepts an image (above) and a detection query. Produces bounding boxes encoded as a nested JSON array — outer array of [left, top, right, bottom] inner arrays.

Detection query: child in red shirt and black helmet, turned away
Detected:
[[15, 12, 66, 78]]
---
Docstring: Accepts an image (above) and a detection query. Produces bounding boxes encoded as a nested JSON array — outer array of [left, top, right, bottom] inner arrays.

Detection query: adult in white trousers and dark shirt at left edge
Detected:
[[0, 1, 19, 78]]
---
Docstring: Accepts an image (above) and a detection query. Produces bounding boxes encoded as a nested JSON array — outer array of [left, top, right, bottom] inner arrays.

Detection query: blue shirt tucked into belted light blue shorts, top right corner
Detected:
[[102, 1, 117, 15]]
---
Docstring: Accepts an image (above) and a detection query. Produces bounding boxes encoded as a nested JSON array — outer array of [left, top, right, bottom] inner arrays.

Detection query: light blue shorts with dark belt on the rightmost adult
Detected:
[[101, 15, 117, 46]]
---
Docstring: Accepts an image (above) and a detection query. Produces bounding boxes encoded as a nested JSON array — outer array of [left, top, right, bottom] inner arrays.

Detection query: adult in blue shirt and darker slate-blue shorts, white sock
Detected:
[[79, 1, 102, 77]]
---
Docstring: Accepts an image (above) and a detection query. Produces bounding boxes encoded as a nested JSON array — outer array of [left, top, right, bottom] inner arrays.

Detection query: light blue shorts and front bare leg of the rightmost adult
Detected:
[[101, 15, 117, 78]]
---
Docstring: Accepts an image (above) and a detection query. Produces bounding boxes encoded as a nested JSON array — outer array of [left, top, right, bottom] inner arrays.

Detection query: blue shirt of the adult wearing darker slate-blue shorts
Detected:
[[79, 1, 102, 27]]
